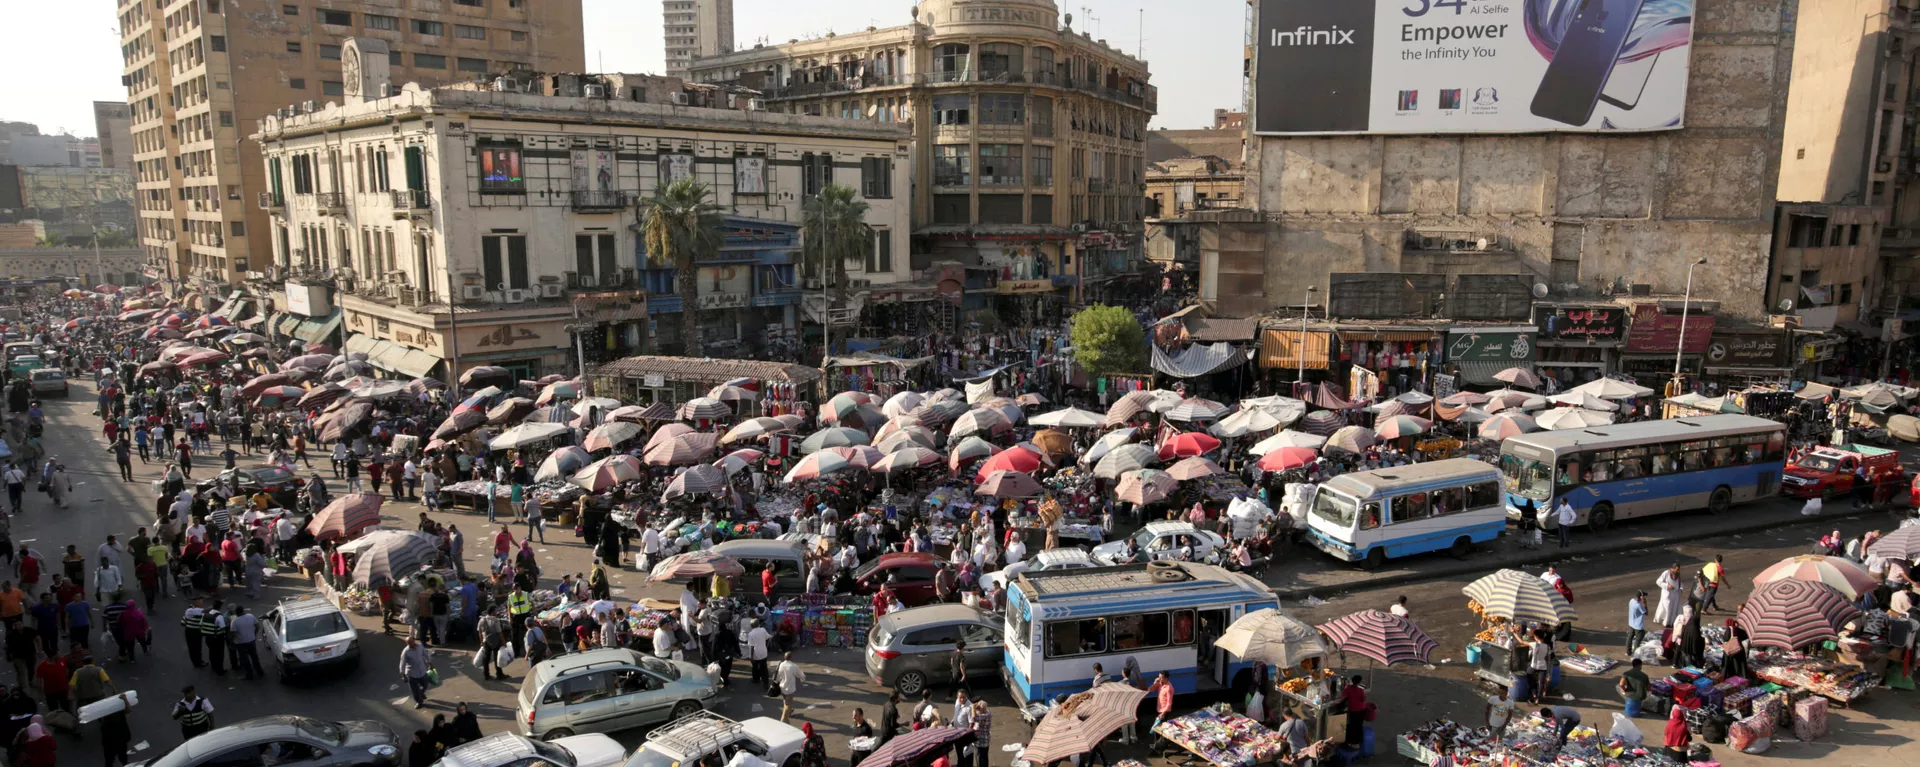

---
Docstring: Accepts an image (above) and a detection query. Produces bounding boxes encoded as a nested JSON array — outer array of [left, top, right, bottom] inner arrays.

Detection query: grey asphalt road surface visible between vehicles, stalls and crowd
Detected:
[[26, 383, 1920, 765]]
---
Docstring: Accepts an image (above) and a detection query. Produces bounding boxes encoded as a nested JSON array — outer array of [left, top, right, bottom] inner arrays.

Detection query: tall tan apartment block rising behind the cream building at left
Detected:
[[119, 0, 586, 290]]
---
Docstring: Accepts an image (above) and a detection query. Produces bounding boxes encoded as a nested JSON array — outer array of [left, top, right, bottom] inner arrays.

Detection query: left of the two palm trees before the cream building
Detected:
[[639, 179, 722, 358]]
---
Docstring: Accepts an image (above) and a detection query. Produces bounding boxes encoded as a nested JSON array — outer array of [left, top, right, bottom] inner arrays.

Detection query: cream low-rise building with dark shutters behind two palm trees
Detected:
[[252, 49, 912, 377]]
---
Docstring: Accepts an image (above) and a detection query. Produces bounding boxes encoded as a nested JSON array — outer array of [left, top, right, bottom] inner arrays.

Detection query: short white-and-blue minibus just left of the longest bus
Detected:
[[1308, 458, 1507, 569]]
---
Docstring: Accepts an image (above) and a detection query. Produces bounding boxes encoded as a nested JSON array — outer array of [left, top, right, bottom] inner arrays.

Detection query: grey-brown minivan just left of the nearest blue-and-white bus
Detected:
[[866, 604, 1004, 698]]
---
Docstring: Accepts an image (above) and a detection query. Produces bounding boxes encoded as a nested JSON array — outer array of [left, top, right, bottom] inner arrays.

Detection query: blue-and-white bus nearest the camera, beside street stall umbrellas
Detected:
[[1000, 561, 1279, 707]]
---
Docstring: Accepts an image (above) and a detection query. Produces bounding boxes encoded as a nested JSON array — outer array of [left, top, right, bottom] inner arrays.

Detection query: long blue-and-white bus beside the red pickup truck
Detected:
[[1500, 415, 1788, 531]]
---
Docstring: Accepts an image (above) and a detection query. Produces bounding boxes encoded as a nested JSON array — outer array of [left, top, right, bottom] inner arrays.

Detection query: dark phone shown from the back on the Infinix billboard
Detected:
[[1532, 0, 1645, 125]]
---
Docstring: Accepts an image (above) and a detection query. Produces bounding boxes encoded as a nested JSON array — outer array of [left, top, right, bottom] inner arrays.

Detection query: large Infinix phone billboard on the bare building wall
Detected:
[[1254, 0, 1695, 135]]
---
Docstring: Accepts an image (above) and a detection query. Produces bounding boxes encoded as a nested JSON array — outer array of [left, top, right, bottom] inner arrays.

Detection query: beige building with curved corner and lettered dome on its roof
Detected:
[[693, 0, 1158, 315]]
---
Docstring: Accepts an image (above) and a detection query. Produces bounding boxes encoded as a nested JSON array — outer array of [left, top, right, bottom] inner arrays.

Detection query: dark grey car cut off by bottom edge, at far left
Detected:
[[134, 715, 401, 767]]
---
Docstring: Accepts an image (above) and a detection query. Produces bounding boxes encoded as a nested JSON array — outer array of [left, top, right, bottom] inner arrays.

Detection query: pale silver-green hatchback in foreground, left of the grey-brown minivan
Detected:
[[516, 648, 720, 740]]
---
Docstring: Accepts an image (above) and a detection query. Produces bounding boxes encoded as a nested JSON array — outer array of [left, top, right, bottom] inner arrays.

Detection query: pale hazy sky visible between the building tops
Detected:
[[0, 0, 1246, 136]]
